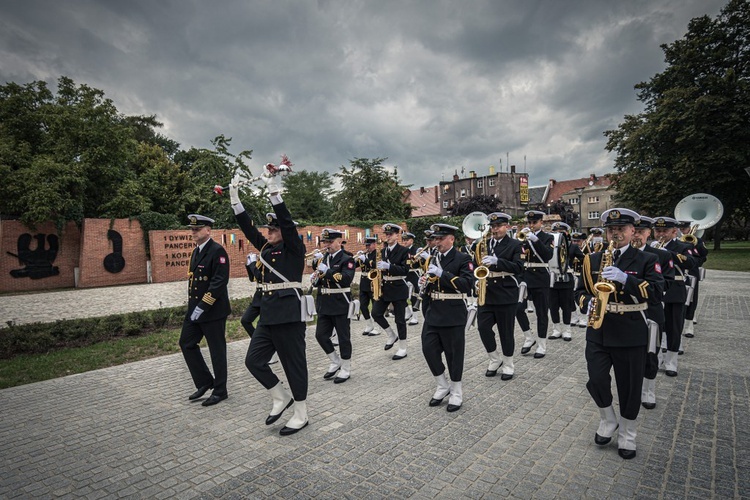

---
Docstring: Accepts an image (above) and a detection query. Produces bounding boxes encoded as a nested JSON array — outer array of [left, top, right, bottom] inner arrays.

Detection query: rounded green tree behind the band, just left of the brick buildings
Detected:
[[334, 158, 411, 220]]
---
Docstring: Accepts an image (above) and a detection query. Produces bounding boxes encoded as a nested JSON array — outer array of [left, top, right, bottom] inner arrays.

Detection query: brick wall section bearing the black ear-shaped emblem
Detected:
[[78, 219, 147, 288]]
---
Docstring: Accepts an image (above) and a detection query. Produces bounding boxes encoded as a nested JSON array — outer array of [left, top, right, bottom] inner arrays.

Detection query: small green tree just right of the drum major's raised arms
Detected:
[[283, 170, 334, 222]]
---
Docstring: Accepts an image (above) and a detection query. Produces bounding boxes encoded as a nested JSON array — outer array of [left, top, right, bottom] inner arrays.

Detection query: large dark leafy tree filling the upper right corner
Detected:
[[605, 0, 750, 249]]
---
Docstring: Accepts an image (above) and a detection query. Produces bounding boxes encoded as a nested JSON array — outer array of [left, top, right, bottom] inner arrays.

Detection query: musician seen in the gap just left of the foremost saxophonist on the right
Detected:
[[549, 222, 583, 342]]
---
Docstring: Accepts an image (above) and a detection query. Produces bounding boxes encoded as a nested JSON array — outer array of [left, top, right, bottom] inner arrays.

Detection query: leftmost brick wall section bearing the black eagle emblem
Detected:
[[0, 220, 81, 293]]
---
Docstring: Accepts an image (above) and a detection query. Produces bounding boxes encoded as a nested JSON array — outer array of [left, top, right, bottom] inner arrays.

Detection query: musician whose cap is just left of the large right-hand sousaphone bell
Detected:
[[652, 217, 698, 377]]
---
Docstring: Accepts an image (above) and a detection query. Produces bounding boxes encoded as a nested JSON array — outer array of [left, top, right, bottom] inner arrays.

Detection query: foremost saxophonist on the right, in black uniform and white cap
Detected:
[[576, 208, 664, 459]]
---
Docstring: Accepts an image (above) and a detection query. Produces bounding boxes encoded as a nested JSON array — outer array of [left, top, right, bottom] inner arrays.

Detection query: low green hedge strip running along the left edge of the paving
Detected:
[[0, 297, 251, 359]]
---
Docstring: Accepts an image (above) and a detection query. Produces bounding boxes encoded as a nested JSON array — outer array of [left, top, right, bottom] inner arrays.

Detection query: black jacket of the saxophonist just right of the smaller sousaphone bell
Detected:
[[476, 235, 524, 306]]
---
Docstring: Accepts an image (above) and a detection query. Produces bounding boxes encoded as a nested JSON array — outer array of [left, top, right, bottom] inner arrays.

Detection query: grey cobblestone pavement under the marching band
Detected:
[[0, 271, 750, 499]]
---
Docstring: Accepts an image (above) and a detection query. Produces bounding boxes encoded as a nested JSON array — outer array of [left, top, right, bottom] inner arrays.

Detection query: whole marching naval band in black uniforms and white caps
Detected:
[[181, 161, 710, 459]]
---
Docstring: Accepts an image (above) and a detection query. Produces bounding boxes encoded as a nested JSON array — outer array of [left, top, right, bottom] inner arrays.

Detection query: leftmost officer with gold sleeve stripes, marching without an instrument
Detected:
[[180, 214, 232, 406]]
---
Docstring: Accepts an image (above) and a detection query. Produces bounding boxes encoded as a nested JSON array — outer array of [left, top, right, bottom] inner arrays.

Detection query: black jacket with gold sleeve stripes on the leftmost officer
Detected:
[[187, 239, 232, 323]]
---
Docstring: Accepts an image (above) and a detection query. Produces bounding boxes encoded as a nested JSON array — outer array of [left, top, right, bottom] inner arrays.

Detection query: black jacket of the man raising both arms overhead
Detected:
[[235, 202, 305, 325]]
